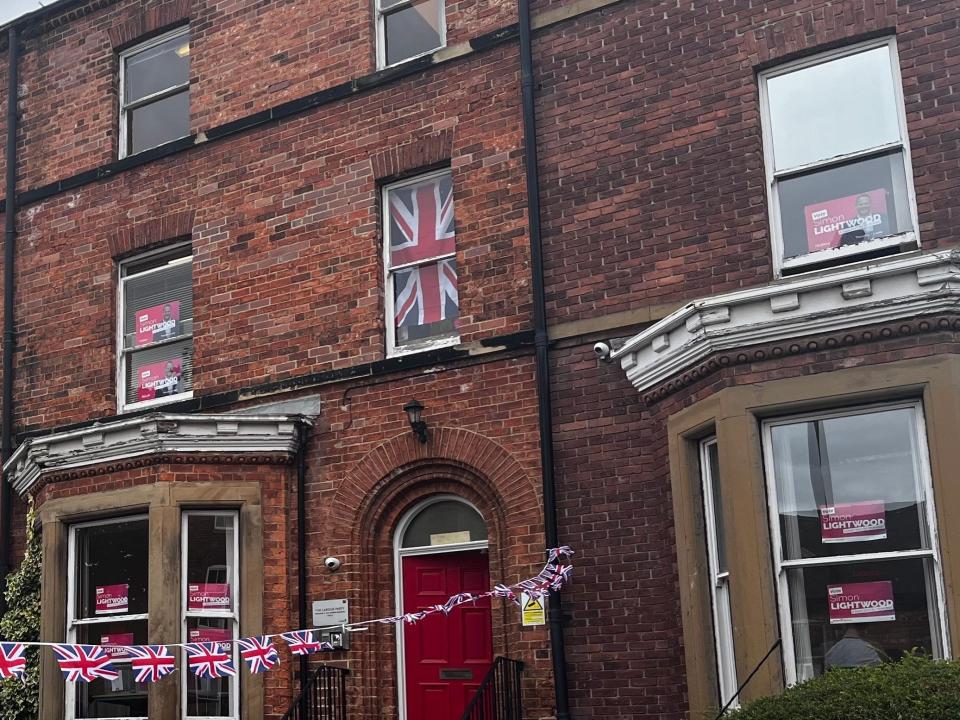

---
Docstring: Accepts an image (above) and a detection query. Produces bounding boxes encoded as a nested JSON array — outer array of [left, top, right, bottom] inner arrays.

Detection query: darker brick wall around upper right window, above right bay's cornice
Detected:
[[534, 0, 960, 321]]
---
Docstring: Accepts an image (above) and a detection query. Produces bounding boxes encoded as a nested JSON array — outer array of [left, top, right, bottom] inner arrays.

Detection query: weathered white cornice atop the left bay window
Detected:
[[3, 413, 311, 495]]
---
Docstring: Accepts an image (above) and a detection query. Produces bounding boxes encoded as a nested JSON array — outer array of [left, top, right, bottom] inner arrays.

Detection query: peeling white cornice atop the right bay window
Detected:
[[610, 251, 960, 393]]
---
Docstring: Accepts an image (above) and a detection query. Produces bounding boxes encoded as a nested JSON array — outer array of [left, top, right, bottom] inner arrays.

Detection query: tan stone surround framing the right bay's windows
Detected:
[[667, 355, 960, 717]]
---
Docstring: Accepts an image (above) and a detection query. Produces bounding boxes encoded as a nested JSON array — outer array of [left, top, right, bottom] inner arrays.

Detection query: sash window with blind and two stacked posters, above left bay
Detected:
[[117, 245, 193, 411]]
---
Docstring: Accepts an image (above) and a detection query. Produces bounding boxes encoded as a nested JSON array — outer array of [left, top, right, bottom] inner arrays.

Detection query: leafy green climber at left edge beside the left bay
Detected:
[[0, 506, 42, 720]]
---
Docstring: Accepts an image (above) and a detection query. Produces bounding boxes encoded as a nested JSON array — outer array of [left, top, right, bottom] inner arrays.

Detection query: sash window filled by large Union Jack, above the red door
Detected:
[[387, 173, 460, 346]]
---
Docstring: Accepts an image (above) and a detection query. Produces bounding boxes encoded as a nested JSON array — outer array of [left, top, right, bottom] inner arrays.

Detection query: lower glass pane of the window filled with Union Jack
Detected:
[[393, 258, 460, 346]]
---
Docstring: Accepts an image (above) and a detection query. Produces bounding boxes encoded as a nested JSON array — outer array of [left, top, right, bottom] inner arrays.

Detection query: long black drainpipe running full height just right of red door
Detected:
[[518, 0, 570, 720]]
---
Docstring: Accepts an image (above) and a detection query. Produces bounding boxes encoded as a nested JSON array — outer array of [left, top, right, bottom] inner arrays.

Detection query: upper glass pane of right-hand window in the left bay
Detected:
[[186, 514, 235, 612]]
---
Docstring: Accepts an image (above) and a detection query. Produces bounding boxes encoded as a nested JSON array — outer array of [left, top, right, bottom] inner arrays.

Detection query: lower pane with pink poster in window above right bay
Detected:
[[777, 152, 913, 258]]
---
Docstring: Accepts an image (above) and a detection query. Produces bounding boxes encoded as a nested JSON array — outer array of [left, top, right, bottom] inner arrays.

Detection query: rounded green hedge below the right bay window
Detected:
[[726, 655, 960, 720]]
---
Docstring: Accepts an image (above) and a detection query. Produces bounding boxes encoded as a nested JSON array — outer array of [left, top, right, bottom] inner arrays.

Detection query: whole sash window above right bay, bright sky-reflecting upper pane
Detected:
[[760, 38, 917, 273]]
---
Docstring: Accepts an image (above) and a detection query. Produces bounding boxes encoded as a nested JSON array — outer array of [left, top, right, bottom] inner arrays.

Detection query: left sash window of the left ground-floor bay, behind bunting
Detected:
[[65, 516, 150, 720]]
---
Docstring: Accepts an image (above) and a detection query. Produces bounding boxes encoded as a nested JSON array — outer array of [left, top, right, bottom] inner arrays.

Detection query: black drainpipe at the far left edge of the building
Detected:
[[0, 25, 20, 613]]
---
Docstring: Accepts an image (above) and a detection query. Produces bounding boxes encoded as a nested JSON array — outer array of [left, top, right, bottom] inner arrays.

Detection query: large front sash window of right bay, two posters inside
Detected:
[[764, 403, 946, 683]]
